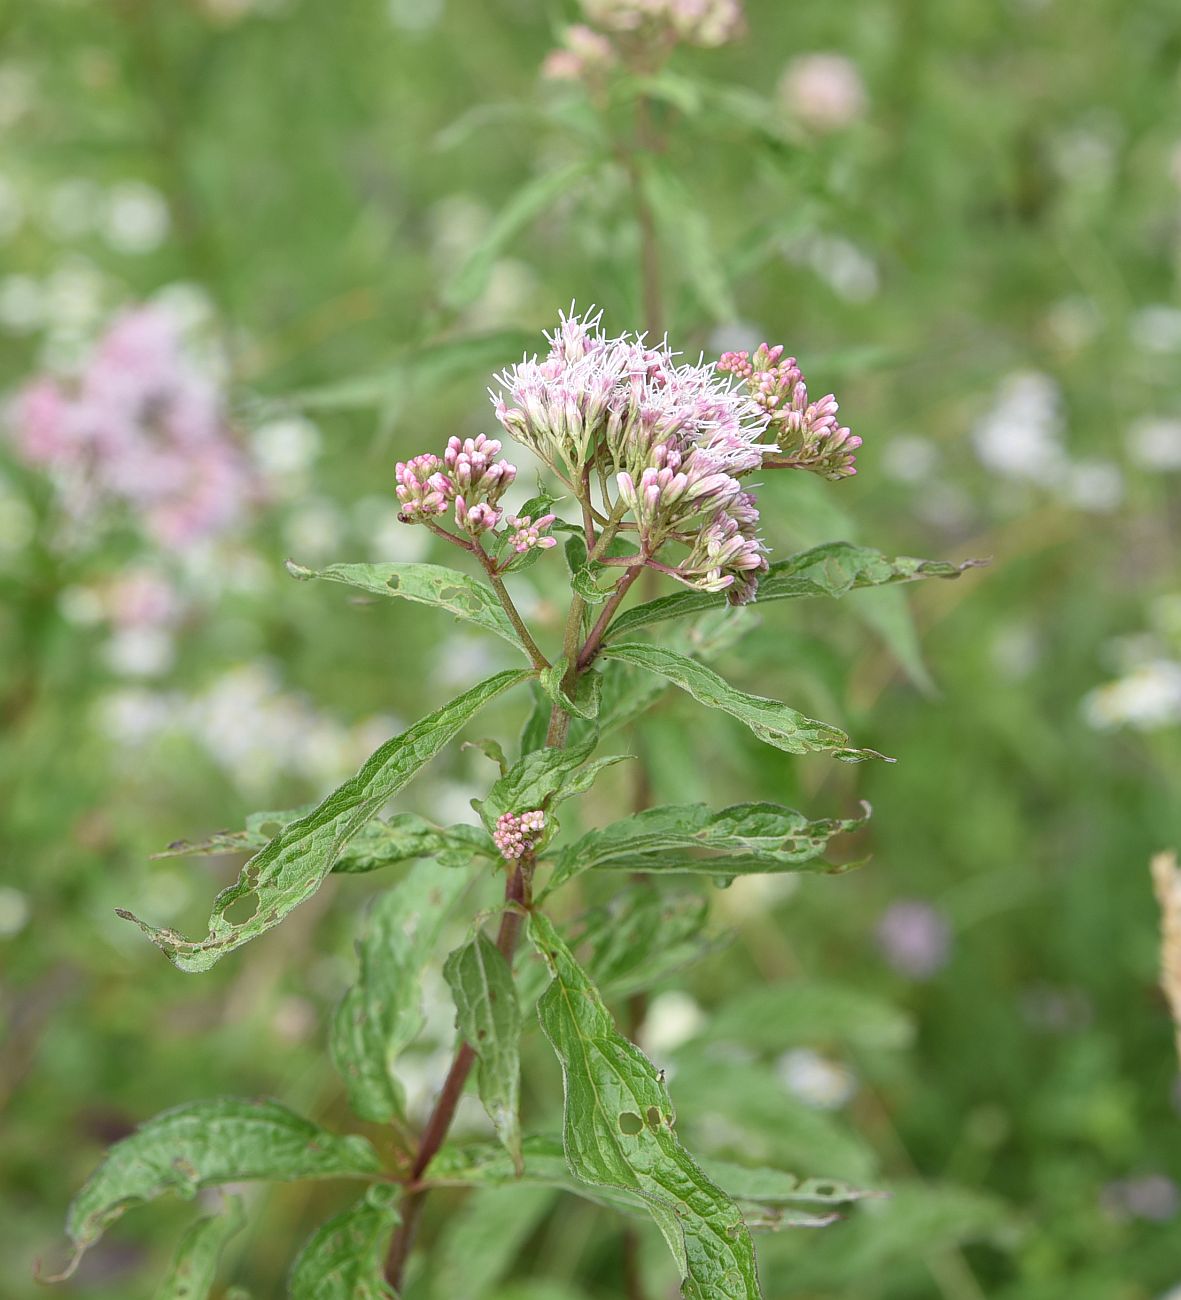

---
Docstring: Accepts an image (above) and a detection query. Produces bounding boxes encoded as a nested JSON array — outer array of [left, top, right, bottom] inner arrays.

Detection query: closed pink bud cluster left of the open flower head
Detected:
[[394, 433, 520, 537]]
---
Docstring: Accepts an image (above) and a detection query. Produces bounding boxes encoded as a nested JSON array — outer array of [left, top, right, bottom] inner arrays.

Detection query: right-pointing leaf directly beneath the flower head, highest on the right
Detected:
[[607, 542, 986, 640]]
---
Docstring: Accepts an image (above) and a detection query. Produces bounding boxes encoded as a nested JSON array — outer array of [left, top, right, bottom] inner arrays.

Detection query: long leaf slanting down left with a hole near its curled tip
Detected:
[[118, 671, 529, 971]]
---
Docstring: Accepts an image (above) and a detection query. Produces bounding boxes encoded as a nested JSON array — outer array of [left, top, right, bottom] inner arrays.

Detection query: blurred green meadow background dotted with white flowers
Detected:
[[0, 0, 1181, 1300]]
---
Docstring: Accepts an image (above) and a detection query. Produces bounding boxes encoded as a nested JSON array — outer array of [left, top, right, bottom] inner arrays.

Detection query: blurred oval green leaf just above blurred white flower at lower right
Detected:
[[704, 979, 914, 1052]]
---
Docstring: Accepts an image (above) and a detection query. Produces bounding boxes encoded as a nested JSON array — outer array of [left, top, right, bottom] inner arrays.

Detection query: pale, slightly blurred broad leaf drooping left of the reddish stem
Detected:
[[329, 862, 468, 1123]]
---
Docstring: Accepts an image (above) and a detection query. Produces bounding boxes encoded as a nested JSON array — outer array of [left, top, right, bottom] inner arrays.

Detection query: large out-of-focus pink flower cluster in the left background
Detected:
[[9, 307, 258, 550]]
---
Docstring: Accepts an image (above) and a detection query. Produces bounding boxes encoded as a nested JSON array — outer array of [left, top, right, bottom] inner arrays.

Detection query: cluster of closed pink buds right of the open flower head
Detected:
[[718, 343, 861, 478]]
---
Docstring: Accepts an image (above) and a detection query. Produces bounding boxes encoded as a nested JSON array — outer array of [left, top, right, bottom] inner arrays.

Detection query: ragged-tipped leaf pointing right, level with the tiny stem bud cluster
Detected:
[[551, 803, 869, 887]]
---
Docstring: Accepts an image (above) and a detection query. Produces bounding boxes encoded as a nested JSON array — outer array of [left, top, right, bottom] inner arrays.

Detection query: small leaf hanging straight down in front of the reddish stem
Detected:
[[444, 927, 520, 1167]]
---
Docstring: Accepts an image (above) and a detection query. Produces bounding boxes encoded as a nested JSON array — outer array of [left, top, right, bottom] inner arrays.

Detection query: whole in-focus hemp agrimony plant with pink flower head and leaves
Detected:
[[48, 306, 978, 1300]]
